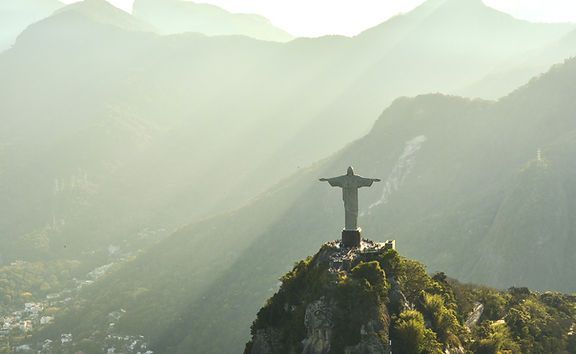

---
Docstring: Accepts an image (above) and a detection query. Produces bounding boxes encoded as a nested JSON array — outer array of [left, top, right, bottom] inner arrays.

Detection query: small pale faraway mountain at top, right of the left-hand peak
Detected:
[[133, 0, 292, 42]]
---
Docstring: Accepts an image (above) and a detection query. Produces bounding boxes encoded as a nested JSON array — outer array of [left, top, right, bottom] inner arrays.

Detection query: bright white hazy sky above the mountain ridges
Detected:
[[64, 0, 576, 36]]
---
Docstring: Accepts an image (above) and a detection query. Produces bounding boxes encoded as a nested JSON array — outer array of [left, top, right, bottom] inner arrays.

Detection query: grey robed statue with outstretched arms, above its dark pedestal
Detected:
[[320, 166, 380, 231]]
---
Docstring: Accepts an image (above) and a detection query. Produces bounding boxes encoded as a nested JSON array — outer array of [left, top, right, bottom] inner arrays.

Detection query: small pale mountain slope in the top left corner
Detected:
[[0, 0, 64, 51]]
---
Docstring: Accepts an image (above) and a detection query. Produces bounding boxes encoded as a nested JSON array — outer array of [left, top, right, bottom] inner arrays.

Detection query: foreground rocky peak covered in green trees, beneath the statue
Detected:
[[244, 239, 576, 354]]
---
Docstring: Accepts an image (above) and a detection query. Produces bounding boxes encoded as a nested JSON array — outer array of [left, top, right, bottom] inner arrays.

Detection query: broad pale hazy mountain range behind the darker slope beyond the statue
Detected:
[[0, 0, 572, 259]]
